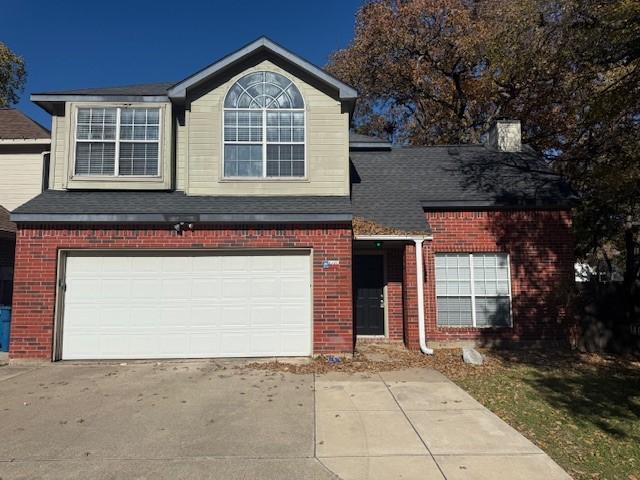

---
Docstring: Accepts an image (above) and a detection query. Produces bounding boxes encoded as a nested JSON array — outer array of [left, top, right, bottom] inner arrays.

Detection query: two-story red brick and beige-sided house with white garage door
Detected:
[[10, 38, 573, 360]]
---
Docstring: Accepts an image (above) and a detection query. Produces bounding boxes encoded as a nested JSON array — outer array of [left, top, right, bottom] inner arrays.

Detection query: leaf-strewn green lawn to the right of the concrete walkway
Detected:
[[453, 352, 640, 480]]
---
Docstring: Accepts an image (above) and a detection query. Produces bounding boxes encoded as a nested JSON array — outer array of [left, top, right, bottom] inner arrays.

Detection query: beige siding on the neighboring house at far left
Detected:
[[0, 149, 49, 211]]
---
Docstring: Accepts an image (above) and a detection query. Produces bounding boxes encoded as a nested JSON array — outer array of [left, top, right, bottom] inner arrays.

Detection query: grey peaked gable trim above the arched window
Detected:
[[169, 36, 358, 101]]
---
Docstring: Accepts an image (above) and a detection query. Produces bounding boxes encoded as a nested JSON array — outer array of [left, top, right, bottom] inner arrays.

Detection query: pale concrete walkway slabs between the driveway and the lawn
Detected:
[[315, 369, 571, 480]]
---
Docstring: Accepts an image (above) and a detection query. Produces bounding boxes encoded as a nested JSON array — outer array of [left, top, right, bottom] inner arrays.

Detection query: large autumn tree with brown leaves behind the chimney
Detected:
[[328, 0, 640, 322]]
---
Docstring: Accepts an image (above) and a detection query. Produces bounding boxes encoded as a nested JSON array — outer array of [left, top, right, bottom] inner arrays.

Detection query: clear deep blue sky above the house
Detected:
[[0, 0, 362, 128]]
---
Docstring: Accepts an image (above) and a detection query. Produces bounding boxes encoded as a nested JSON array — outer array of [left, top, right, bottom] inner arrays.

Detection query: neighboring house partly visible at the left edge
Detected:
[[0, 108, 51, 305]]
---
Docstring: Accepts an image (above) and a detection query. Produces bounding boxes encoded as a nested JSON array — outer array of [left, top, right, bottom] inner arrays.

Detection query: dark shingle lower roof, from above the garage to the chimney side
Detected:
[[13, 145, 574, 233]]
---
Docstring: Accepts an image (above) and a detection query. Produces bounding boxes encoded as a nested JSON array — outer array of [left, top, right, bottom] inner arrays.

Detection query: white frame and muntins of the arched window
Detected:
[[222, 70, 308, 181]]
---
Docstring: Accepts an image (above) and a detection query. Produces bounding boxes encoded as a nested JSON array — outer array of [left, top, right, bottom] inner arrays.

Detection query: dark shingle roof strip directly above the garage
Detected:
[[12, 190, 351, 221]]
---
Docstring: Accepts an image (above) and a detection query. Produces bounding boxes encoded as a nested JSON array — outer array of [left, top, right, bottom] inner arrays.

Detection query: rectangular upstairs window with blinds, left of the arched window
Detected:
[[74, 107, 160, 176]]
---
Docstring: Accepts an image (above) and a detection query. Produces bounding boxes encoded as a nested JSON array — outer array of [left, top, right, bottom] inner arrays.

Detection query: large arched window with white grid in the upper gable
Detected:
[[224, 72, 305, 177]]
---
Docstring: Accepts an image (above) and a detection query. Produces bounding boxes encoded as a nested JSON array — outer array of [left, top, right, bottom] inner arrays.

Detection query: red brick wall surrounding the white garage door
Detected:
[[10, 225, 353, 358]]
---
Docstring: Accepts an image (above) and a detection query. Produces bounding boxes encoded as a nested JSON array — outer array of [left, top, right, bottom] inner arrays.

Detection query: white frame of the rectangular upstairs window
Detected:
[[72, 105, 163, 179]]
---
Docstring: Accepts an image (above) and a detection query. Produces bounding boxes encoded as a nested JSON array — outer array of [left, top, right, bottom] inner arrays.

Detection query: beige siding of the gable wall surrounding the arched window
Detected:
[[186, 61, 349, 195]]
